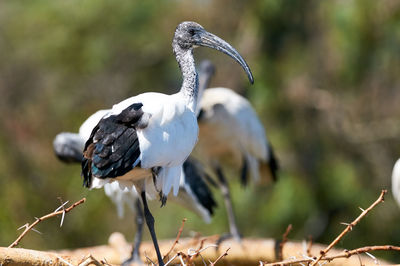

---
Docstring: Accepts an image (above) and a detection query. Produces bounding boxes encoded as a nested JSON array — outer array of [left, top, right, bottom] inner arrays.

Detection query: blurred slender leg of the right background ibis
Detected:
[[215, 166, 241, 243]]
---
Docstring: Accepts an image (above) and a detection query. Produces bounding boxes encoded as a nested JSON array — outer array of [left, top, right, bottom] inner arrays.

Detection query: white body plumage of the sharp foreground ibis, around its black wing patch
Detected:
[[87, 92, 198, 197]]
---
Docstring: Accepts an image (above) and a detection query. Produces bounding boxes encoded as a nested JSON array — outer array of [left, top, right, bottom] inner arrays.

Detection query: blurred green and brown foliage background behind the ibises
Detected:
[[0, 0, 400, 262]]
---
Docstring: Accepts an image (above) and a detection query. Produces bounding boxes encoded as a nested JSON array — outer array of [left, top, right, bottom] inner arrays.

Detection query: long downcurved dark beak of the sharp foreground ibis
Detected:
[[195, 30, 254, 84]]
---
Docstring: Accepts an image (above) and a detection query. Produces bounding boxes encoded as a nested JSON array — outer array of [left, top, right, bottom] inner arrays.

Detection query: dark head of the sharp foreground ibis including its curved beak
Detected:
[[172, 21, 254, 83]]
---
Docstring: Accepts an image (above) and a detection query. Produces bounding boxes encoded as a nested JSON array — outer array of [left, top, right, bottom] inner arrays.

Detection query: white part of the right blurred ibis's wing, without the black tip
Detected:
[[199, 88, 268, 161]]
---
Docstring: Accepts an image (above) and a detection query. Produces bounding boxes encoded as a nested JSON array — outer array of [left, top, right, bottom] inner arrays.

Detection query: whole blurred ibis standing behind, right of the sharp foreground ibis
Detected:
[[193, 61, 278, 241]]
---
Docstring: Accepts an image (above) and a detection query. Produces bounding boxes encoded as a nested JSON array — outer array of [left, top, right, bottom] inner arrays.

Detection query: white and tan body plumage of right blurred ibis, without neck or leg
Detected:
[[195, 88, 273, 182]]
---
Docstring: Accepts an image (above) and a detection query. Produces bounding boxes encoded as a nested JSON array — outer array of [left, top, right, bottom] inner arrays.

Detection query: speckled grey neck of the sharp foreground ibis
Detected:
[[174, 45, 199, 112]]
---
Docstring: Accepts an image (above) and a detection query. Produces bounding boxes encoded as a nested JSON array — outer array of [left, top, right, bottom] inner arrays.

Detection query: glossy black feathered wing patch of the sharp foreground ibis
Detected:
[[82, 103, 147, 187]]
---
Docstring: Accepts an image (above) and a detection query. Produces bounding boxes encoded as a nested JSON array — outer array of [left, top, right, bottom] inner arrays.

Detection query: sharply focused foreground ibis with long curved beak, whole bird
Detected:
[[82, 22, 253, 265]]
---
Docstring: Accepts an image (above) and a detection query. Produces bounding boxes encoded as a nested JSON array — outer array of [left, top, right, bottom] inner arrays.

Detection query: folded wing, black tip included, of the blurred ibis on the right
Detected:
[[199, 88, 278, 183]]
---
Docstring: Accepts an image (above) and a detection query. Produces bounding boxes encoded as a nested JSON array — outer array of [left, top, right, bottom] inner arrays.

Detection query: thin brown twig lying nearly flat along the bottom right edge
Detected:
[[263, 245, 400, 266]]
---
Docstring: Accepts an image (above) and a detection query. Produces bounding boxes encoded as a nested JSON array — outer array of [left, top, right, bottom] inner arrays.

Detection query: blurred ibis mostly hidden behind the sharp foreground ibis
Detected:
[[53, 128, 216, 265]]
